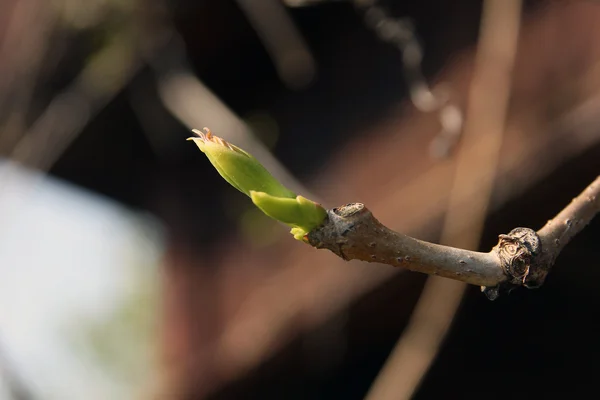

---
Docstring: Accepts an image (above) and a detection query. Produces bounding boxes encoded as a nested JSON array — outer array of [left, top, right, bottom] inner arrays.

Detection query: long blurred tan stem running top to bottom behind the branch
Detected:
[[360, 0, 521, 400]]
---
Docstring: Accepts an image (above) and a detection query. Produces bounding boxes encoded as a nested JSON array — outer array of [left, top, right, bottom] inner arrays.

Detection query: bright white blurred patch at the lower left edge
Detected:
[[0, 162, 164, 400]]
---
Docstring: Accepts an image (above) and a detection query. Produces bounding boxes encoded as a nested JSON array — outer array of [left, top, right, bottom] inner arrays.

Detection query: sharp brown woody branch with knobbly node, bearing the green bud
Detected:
[[307, 176, 600, 300]]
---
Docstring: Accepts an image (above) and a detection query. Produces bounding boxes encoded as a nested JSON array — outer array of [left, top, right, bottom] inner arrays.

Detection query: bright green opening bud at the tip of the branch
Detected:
[[188, 128, 327, 240]]
